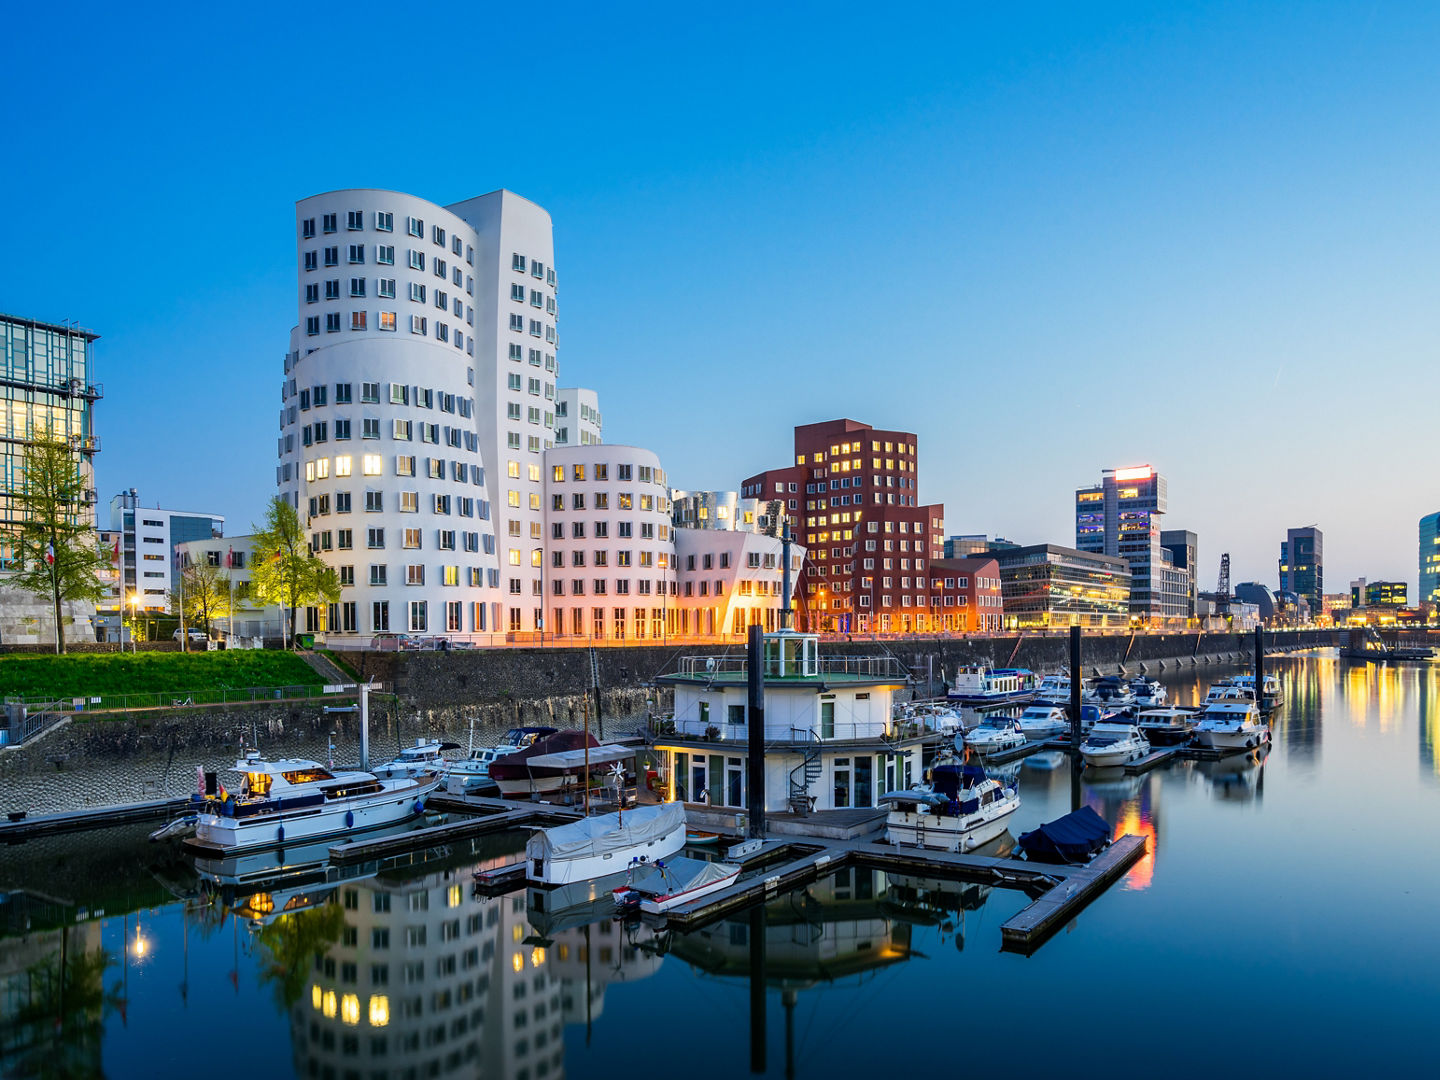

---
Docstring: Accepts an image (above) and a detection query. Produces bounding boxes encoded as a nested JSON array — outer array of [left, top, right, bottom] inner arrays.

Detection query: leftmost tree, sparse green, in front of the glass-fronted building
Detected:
[[10, 428, 108, 652]]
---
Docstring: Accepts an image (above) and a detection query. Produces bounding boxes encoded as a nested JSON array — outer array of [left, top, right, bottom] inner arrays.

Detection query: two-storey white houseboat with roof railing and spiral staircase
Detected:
[[654, 629, 940, 822]]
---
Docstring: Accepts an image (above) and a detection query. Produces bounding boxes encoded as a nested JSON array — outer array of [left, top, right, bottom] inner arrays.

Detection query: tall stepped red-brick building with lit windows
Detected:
[[740, 420, 944, 634]]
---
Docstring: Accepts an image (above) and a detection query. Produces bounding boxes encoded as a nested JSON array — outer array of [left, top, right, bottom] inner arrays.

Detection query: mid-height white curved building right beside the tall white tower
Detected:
[[546, 444, 678, 641]]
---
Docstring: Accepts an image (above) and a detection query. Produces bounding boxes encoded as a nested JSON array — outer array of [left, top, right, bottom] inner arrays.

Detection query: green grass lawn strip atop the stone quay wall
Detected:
[[0, 649, 321, 704]]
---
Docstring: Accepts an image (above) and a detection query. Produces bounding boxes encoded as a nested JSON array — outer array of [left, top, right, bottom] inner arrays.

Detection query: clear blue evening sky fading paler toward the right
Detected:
[[0, 3, 1440, 590]]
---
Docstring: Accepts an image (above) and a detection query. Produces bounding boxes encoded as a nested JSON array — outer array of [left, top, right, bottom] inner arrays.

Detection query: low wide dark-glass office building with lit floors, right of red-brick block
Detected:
[[994, 544, 1130, 629]]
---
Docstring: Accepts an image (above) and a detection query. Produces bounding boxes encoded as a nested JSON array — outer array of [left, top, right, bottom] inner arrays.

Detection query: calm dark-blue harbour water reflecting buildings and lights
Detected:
[[0, 657, 1440, 1080]]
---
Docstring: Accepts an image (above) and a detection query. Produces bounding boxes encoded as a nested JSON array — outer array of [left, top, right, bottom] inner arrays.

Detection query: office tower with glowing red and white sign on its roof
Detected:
[[1077, 465, 1194, 624]]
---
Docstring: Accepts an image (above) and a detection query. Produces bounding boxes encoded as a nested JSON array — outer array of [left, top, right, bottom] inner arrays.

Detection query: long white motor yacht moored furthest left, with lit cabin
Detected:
[[186, 750, 441, 854]]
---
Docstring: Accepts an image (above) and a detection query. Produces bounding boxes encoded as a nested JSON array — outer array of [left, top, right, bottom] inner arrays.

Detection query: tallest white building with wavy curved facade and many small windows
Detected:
[[276, 189, 559, 641]]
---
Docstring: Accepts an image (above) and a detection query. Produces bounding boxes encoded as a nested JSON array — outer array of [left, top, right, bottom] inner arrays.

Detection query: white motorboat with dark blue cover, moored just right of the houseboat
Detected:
[[880, 763, 1020, 851]]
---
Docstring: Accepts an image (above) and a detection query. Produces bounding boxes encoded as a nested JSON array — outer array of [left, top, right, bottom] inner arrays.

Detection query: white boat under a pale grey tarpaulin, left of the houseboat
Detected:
[[526, 802, 685, 886]]
